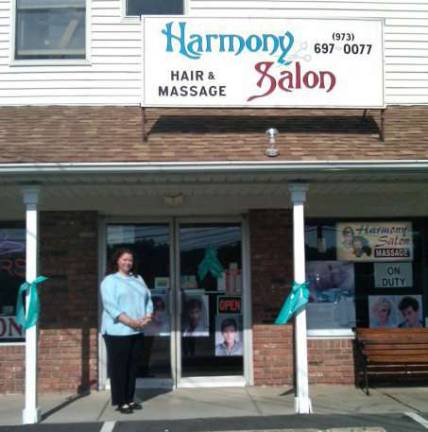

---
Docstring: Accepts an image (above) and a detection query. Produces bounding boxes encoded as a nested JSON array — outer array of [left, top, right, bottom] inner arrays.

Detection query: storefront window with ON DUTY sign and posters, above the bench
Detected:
[[306, 220, 425, 334]]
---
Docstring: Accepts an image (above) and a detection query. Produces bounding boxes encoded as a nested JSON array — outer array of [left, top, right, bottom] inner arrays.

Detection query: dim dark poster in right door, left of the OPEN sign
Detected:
[[182, 292, 209, 337]]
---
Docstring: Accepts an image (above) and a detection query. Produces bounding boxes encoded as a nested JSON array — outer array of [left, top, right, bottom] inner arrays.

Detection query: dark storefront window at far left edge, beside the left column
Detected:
[[0, 225, 25, 343]]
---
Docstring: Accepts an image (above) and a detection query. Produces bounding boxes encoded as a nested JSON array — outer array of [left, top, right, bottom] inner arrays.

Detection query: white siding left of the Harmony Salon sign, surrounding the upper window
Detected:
[[0, 0, 141, 105]]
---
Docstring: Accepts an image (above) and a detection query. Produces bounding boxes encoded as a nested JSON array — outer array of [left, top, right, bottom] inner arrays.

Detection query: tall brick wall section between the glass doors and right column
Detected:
[[249, 210, 293, 385]]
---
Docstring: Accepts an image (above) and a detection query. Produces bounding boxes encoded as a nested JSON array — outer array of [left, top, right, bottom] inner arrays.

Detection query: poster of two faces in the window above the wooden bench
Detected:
[[369, 295, 424, 328]]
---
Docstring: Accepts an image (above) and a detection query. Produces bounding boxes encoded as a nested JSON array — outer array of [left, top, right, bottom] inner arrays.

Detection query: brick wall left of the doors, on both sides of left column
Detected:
[[0, 212, 98, 393]]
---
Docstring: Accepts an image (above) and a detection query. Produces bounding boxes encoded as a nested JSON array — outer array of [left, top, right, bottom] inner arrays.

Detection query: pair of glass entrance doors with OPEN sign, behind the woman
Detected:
[[106, 220, 244, 387]]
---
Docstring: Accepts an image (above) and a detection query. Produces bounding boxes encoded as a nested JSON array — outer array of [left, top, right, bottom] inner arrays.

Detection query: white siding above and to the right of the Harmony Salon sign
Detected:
[[189, 0, 428, 104]]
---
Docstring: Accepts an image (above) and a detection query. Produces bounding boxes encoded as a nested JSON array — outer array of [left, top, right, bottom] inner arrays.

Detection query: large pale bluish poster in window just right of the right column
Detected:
[[306, 261, 356, 329]]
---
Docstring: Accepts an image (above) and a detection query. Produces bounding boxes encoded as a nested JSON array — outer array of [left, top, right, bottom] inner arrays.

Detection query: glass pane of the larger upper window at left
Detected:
[[15, 0, 86, 60]]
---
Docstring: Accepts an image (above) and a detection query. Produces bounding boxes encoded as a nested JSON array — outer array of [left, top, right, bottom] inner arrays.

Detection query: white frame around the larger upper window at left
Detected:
[[9, 0, 92, 66]]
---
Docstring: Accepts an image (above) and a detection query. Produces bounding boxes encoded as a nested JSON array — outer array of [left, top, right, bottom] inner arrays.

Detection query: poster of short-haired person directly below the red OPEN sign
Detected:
[[215, 314, 242, 357]]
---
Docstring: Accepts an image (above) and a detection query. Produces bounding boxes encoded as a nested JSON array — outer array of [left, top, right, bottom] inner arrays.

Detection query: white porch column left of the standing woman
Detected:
[[22, 186, 40, 424]]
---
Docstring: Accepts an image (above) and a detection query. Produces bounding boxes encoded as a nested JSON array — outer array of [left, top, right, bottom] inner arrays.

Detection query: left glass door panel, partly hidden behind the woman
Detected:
[[107, 223, 174, 383]]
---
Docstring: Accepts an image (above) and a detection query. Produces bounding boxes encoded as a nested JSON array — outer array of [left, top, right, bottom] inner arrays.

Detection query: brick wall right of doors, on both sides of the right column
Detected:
[[250, 210, 354, 385]]
